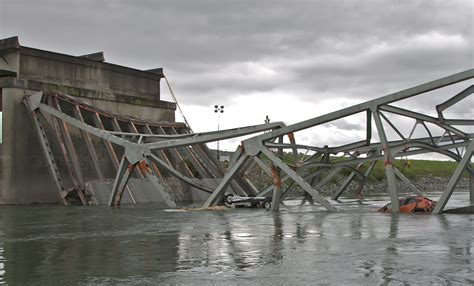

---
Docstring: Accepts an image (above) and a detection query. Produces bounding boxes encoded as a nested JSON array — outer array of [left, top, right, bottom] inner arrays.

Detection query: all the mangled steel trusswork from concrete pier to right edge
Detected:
[[24, 69, 474, 214]]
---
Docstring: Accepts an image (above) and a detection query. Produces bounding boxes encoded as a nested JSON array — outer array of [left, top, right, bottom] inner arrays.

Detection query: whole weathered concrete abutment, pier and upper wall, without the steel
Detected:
[[0, 37, 176, 204]]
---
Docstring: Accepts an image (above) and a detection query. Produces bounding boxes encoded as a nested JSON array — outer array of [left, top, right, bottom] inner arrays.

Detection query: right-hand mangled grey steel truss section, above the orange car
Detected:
[[204, 69, 474, 213]]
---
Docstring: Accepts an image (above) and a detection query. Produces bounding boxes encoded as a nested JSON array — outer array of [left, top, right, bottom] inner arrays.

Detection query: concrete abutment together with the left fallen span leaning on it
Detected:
[[0, 37, 281, 207]]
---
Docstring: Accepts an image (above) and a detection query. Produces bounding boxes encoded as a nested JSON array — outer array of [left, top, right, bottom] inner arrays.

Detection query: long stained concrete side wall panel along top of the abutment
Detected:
[[19, 47, 161, 100]]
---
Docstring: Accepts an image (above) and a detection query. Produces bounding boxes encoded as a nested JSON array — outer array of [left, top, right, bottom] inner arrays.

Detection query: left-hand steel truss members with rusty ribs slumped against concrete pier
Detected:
[[24, 92, 284, 208]]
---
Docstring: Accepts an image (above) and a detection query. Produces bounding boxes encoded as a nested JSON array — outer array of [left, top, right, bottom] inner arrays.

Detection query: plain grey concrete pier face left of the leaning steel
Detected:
[[0, 88, 58, 204]]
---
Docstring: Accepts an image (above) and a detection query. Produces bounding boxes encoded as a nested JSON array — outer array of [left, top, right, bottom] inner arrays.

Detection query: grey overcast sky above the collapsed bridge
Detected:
[[0, 0, 474, 149]]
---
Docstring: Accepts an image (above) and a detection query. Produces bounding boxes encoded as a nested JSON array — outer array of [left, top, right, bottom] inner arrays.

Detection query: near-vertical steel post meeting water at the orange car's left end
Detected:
[[372, 106, 400, 213]]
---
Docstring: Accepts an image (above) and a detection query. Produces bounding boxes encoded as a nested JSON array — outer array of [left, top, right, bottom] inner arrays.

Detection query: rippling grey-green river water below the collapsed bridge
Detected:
[[0, 193, 474, 285]]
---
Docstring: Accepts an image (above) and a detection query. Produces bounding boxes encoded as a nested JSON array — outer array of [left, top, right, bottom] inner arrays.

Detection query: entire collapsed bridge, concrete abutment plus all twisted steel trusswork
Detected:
[[0, 38, 474, 213]]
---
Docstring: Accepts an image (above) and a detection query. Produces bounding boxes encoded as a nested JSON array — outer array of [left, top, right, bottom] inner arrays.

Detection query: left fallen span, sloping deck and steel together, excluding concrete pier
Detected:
[[24, 92, 281, 208]]
